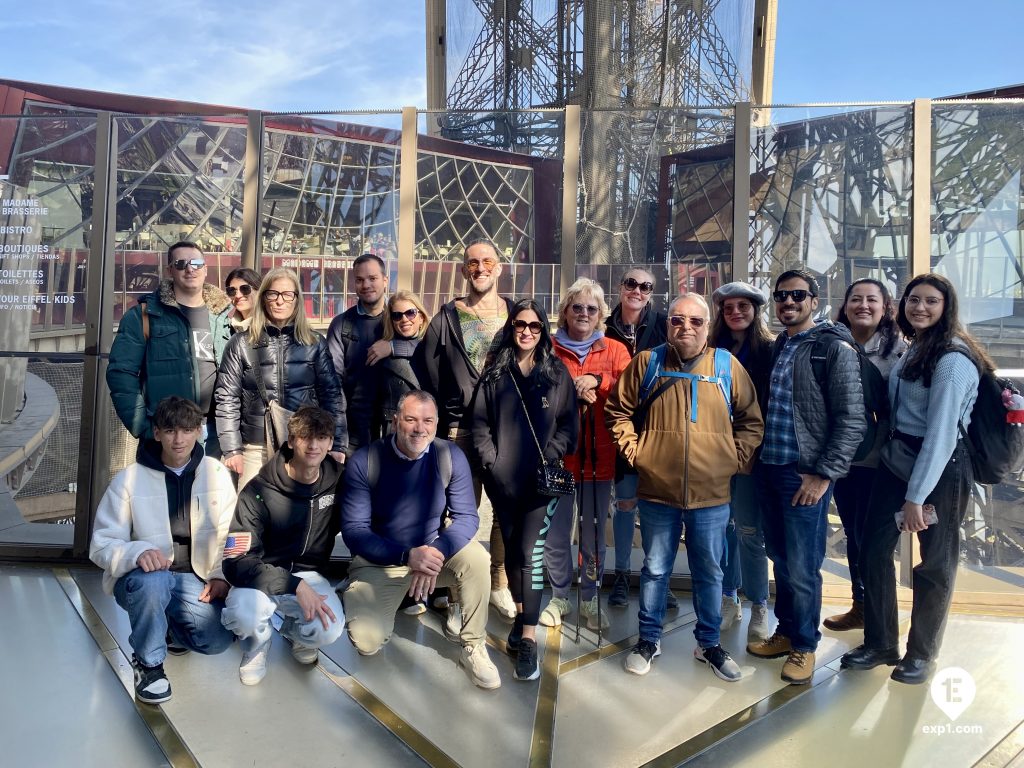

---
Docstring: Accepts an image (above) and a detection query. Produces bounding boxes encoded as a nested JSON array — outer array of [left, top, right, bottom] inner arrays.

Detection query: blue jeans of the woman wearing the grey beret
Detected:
[[722, 475, 768, 604]]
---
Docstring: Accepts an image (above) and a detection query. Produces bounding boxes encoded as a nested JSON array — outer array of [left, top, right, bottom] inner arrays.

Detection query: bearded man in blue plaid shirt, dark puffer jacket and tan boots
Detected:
[[746, 269, 866, 685]]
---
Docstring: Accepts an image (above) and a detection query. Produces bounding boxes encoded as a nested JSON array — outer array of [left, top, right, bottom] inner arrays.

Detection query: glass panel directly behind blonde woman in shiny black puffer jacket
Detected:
[[261, 114, 401, 329]]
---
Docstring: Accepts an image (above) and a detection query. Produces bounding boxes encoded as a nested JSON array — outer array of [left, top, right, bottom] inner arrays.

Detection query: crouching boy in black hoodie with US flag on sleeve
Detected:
[[223, 406, 345, 685]]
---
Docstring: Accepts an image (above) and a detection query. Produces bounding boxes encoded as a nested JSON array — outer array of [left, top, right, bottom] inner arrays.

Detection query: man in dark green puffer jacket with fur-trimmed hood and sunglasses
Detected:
[[106, 241, 231, 458]]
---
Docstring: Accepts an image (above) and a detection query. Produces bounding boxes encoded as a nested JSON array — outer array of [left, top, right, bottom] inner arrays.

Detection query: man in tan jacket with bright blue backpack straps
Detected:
[[604, 294, 764, 682]]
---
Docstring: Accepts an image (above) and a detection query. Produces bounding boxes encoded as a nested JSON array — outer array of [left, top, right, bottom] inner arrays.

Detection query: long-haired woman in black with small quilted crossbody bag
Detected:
[[470, 299, 580, 680]]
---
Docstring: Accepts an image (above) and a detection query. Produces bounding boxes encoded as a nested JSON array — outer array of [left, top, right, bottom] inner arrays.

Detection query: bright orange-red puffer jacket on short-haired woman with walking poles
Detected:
[[554, 338, 630, 481]]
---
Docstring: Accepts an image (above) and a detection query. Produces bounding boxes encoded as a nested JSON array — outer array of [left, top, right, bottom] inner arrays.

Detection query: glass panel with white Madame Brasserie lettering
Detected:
[[0, 115, 96, 546]]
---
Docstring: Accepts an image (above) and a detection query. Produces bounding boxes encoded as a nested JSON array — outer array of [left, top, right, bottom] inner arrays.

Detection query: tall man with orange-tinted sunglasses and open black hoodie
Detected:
[[415, 238, 516, 634]]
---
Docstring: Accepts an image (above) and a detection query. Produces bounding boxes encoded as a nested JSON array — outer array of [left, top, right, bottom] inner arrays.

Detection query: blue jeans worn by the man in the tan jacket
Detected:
[[640, 499, 729, 648]]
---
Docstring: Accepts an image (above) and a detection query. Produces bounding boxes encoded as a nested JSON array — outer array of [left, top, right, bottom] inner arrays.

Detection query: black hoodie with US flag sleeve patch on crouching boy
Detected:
[[223, 444, 342, 595]]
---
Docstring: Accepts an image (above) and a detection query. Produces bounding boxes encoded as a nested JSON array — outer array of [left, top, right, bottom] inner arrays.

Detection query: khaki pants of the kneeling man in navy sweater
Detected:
[[342, 541, 490, 655]]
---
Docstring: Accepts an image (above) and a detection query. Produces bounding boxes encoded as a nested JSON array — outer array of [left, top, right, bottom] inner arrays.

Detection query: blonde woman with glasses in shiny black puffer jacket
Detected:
[[213, 268, 348, 489]]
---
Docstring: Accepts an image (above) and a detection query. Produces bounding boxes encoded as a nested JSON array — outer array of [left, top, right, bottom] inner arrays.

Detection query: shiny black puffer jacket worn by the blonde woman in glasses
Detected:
[[213, 324, 348, 457]]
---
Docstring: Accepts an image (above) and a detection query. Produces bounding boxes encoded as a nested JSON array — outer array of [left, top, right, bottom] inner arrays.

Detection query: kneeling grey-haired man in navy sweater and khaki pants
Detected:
[[341, 390, 501, 688]]
